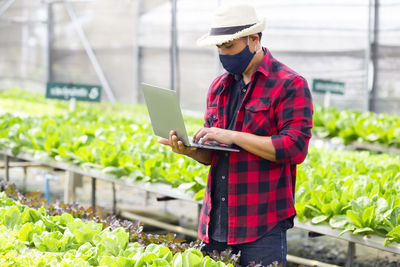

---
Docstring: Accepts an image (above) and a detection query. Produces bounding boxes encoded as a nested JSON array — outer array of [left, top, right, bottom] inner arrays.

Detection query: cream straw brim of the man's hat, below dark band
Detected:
[[197, 18, 265, 47]]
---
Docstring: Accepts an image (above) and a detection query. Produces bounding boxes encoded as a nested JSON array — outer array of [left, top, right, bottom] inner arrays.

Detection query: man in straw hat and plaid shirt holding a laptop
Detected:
[[159, 5, 313, 266]]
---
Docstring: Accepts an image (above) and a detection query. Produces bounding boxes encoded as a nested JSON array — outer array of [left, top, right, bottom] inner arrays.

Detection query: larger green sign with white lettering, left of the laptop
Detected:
[[46, 82, 101, 102]]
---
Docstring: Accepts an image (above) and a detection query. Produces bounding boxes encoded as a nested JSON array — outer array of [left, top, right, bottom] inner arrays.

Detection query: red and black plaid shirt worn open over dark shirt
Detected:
[[198, 48, 313, 244]]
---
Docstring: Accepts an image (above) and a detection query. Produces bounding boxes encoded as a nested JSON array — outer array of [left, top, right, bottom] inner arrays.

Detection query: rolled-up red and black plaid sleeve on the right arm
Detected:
[[271, 77, 313, 164]]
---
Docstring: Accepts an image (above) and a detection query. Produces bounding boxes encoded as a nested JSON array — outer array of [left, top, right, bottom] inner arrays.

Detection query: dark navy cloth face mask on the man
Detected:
[[219, 38, 257, 74]]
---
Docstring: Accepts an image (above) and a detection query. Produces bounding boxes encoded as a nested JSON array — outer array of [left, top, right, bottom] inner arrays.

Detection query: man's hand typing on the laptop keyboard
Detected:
[[193, 127, 236, 145]]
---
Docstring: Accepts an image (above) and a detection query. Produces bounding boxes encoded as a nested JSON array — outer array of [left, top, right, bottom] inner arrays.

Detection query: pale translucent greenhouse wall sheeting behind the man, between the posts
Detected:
[[0, 0, 400, 114]]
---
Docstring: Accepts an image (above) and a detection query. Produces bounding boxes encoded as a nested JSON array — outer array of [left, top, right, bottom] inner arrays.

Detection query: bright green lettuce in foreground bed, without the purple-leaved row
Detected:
[[0, 192, 233, 267]]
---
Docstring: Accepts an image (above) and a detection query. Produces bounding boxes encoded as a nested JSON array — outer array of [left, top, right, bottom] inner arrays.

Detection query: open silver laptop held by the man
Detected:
[[142, 83, 240, 152]]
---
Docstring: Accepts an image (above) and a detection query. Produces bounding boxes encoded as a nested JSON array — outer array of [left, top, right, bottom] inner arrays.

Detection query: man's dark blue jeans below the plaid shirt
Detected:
[[204, 220, 290, 267]]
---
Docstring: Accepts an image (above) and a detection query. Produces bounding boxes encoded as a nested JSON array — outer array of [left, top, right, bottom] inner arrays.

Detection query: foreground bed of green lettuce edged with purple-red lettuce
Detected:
[[0, 184, 238, 267]]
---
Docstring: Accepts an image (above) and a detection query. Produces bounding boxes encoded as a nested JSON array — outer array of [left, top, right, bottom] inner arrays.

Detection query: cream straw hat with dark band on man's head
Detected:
[[197, 4, 265, 47]]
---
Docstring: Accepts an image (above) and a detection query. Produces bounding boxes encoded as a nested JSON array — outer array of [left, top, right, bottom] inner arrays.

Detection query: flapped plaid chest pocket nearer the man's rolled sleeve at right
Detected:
[[243, 98, 273, 136]]
